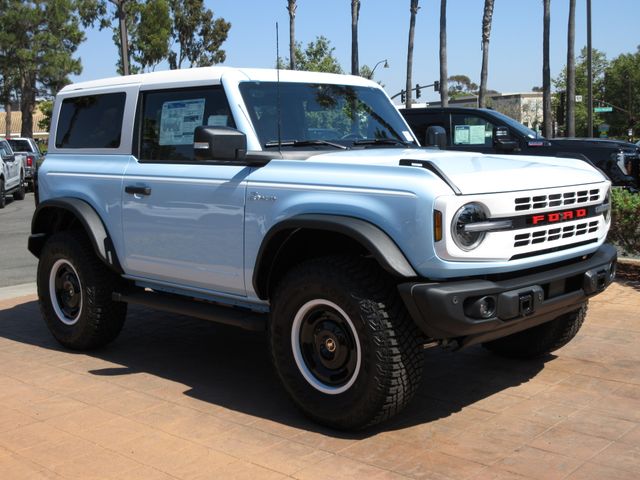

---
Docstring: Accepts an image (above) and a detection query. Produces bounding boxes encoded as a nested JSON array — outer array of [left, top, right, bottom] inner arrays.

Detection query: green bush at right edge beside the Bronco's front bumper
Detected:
[[608, 188, 640, 256]]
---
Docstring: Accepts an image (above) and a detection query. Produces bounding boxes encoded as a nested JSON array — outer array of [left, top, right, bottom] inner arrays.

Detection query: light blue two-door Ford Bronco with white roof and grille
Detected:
[[29, 67, 616, 429]]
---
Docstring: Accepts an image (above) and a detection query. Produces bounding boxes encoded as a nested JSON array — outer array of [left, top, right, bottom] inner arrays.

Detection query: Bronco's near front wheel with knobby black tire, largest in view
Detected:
[[270, 256, 423, 430]]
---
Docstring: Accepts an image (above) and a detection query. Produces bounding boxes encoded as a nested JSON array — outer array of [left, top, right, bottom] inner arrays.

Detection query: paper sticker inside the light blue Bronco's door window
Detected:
[[159, 98, 205, 145]]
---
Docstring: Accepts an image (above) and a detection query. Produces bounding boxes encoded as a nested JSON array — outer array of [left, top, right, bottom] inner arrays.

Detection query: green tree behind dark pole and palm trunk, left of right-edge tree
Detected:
[[553, 48, 609, 137]]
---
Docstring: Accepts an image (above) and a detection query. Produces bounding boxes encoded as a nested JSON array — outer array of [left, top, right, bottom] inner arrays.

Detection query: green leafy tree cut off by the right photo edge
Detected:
[[594, 47, 640, 137]]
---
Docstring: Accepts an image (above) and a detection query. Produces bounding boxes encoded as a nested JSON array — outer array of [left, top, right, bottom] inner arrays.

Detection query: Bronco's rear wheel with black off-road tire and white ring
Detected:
[[37, 230, 127, 350]]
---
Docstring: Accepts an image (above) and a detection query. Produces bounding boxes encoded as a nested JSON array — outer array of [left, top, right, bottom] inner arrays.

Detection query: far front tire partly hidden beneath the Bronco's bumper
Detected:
[[483, 302, 587, 358]]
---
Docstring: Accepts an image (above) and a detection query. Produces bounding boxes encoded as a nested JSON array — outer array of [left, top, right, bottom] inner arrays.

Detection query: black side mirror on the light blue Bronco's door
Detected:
[[193, 125, 247, 162]]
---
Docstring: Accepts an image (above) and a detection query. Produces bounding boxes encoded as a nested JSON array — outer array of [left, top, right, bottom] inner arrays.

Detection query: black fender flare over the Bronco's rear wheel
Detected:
[[28, 197, 123, 273]]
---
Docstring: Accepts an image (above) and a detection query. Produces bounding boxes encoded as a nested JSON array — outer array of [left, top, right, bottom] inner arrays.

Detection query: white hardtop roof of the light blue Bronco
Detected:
[[60, 67, 379, 93]]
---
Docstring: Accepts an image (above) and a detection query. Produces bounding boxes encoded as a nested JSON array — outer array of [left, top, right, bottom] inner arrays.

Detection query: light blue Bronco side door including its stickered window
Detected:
[[122, 86, 251, 295]]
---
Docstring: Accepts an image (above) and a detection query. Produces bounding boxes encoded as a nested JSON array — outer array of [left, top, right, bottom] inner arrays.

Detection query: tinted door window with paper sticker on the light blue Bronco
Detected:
[[139, 87, 235, 162]]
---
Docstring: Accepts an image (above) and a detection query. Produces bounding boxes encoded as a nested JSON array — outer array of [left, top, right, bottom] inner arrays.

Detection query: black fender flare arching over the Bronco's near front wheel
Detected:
[[253, 214, 418, 299]]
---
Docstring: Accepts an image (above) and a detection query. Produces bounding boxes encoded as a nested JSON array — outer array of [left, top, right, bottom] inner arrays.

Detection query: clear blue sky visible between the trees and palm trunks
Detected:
[[73, 0, 640, 101]]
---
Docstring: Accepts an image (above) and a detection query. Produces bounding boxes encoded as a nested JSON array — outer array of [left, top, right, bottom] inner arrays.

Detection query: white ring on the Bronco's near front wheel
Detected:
[[291, 299, 362, 395]]
